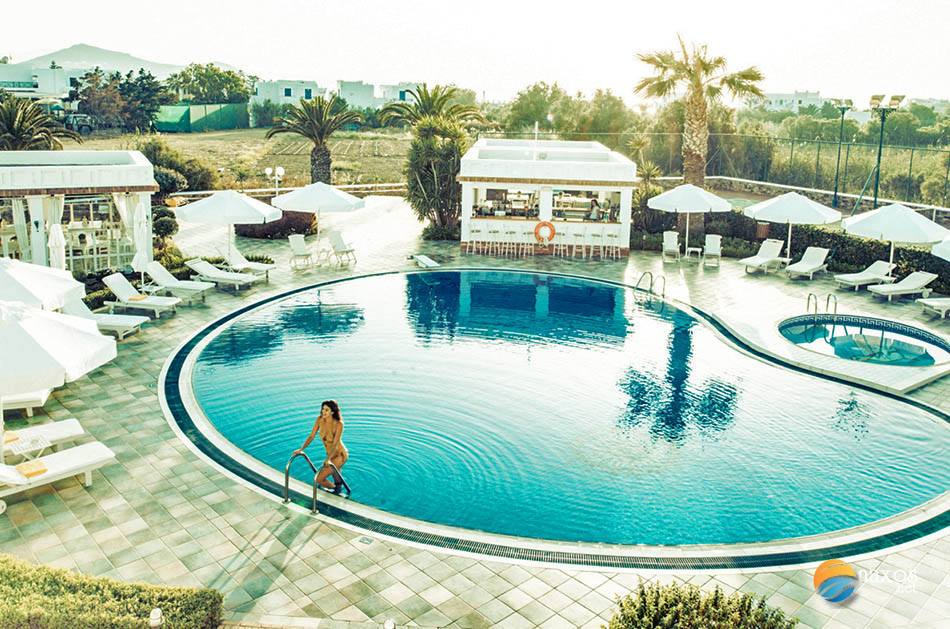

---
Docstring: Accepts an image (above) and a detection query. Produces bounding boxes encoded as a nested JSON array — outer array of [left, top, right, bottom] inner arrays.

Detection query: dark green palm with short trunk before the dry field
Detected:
[[264, 94, 363, 183]]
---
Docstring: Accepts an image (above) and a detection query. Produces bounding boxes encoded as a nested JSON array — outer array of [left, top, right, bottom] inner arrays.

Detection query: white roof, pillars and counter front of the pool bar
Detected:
[[458, 138, 637, 255]]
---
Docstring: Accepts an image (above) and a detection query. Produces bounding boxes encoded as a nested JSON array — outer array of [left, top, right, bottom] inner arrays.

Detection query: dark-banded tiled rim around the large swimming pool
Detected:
[[159, 268, 950, 570]]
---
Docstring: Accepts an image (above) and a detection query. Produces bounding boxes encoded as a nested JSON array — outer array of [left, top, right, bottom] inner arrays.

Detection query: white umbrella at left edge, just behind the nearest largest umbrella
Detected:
[[0, 258, 86, 310]]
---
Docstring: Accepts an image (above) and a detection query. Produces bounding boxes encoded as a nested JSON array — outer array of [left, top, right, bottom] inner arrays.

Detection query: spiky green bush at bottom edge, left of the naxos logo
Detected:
[[608, 582, 797, 629]]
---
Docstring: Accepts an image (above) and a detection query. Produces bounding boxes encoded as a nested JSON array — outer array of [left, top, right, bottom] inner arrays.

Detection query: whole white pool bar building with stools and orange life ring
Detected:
[[458, 138, 637, 257]]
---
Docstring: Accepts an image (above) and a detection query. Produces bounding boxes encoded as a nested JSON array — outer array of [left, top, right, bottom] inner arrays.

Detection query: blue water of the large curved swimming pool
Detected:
[[192, 271, 950, 544]]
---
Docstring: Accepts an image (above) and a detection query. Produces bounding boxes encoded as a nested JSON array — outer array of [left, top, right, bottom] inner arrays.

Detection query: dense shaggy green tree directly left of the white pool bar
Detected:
[[406, 116, 469, 240]]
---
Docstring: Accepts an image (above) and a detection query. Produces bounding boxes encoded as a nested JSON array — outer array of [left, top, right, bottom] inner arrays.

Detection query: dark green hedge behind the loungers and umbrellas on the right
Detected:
[[630, 211, 950, 295]]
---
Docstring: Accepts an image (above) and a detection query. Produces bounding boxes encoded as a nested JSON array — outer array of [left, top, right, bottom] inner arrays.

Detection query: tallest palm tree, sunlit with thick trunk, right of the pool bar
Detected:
[[635, 37, 764, 186]]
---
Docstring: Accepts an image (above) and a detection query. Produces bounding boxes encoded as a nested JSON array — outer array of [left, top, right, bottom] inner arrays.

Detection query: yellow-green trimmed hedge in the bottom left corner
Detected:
[[0, 555, 223, 629]]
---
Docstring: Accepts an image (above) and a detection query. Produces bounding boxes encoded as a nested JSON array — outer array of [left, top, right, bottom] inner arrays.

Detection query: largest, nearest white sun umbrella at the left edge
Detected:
[[0, 301, 116, 461]]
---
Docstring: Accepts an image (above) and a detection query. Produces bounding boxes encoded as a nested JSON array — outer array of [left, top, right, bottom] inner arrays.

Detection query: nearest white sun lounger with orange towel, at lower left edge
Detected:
[[0, 441, 115, 514]]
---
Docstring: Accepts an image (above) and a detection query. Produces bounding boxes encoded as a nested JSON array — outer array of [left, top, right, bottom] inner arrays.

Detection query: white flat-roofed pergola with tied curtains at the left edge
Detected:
[[0, 151, 158, 270]]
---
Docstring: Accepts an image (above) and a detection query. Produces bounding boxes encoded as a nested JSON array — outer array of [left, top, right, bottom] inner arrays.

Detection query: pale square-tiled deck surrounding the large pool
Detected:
[[0, 199, 950, 627]]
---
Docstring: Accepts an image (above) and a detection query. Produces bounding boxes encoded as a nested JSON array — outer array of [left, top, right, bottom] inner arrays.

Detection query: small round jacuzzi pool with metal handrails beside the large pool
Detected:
[[779, 315, 950, 367]]
